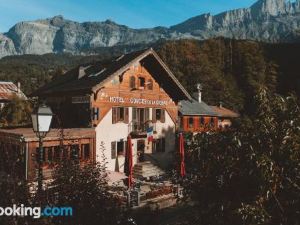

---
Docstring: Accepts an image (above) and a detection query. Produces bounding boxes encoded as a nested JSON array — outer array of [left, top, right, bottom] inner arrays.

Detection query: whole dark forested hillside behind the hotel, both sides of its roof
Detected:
[[0, 39, 300, 112]]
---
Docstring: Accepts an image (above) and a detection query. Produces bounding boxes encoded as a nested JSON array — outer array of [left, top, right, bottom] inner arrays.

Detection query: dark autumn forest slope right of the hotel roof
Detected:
[[158, 39, 300, 112]]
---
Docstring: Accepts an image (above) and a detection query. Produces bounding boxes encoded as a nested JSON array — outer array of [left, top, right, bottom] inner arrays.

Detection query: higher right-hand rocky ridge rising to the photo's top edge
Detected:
[[171, 0, 300, 42]]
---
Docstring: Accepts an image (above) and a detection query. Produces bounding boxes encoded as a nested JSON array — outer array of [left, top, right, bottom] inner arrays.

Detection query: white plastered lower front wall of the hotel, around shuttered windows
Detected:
[[96, 107, 176, 172]]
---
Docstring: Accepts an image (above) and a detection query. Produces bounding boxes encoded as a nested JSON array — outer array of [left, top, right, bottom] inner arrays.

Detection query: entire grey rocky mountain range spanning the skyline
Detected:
[[0, 0, 300, 57]]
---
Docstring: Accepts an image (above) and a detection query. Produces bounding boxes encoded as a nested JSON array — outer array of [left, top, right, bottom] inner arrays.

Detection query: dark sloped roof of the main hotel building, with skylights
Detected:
[[32, 48, 191, 99]]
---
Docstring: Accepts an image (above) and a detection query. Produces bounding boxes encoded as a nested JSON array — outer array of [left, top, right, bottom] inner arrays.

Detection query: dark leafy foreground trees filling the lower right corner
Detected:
[[180, 90, 300, 225]]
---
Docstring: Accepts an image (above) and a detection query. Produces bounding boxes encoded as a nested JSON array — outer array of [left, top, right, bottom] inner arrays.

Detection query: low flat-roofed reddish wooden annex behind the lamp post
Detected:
[[0, 128, 96, 182]]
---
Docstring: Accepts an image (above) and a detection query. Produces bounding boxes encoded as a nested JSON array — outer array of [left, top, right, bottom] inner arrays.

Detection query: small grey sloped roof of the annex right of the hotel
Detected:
[[179, 99, 218, 116]]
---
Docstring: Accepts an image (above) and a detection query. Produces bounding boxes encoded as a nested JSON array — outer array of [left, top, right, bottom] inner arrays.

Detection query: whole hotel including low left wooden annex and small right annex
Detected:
[[0, 49, 239, 180]]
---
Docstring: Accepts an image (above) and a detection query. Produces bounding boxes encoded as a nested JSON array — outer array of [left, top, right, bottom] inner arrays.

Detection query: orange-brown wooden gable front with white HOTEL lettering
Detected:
[[92, 62, 177, 124]]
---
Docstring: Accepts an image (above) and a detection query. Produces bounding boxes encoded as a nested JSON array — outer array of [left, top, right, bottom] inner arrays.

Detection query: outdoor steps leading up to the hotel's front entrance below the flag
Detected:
[[133, 161, 164, 178]]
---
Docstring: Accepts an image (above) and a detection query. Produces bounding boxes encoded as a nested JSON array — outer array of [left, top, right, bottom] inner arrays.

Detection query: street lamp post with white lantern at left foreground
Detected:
[[31, 104, 53, 192]]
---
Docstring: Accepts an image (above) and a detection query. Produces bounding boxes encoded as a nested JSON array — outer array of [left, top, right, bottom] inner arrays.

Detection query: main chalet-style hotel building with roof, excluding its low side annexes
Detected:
[[34, 49, 192, 172]]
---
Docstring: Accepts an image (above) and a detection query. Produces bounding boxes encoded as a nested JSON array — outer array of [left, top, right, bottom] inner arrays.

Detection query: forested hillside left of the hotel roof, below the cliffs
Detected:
[[0, 52, 121, 94]]
